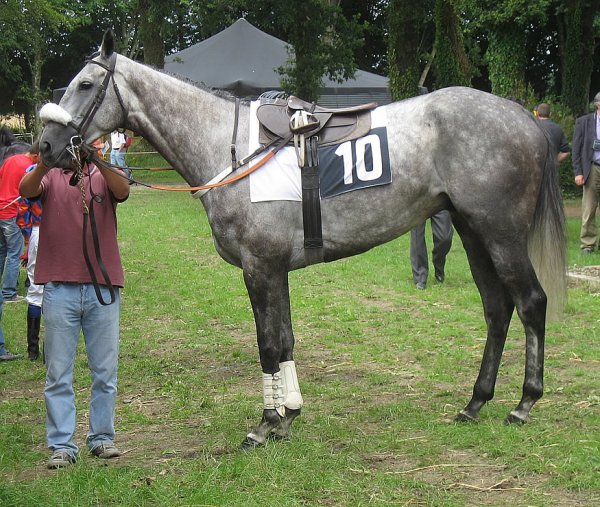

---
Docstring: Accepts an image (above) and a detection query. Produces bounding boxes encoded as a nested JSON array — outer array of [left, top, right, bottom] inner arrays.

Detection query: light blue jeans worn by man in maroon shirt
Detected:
[[42, 282, 121, 456]]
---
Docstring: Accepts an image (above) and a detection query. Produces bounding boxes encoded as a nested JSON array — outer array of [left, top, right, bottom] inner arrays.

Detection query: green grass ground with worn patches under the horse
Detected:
[[0, 188, 600, 507]]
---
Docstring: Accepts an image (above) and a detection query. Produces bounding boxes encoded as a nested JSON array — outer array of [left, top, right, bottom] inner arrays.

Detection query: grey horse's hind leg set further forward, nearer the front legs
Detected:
[[453, 217, 514, 421]]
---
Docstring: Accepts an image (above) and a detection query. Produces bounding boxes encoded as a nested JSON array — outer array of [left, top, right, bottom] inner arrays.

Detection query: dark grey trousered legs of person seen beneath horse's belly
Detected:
[[410, 210, 454, 290]]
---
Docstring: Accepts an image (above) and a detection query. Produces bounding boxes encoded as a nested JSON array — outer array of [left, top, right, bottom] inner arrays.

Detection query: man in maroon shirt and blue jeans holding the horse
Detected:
[[19, 154, 129, 469]]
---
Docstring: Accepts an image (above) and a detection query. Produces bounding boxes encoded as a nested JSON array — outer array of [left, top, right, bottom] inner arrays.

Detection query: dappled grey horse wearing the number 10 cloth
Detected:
[[41, 31, 565, 447]]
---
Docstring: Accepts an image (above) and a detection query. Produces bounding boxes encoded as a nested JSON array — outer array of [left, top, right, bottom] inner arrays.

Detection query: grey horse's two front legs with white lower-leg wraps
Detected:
[[242, 269, 302, 448]]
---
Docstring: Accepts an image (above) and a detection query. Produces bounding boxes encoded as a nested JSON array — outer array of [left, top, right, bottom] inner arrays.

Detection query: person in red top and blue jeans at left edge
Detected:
[[0, 142, 40, 302]]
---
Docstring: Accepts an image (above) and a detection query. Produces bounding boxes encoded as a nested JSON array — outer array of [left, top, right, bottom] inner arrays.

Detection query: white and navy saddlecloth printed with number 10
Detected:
[[249, 101, 392, 202]]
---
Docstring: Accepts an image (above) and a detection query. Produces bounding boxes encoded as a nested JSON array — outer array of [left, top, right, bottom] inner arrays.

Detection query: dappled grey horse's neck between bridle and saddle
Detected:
[[117, 58, 248, 185]]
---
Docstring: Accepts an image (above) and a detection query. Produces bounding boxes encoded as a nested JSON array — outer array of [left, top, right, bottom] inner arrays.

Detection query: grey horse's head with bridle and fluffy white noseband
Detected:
[[40, 29, 126, 167]]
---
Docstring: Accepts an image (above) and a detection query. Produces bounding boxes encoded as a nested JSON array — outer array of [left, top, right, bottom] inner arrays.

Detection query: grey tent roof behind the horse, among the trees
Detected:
[[165, 18, 391, 106]]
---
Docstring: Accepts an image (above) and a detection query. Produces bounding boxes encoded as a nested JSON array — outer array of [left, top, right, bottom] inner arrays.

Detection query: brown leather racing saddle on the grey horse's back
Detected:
[[256, 95, 377, 145]]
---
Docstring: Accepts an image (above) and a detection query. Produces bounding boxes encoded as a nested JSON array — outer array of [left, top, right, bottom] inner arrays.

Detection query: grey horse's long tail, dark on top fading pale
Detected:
[[528, 136, 567, 320]]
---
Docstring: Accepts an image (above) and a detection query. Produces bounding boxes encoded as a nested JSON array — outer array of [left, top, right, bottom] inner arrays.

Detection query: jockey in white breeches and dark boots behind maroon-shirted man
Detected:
[[17, 164, 44, 361]]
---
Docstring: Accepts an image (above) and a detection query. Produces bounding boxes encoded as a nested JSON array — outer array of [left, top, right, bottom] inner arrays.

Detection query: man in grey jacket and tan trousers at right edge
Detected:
[[573, 92, 600, 255]]
